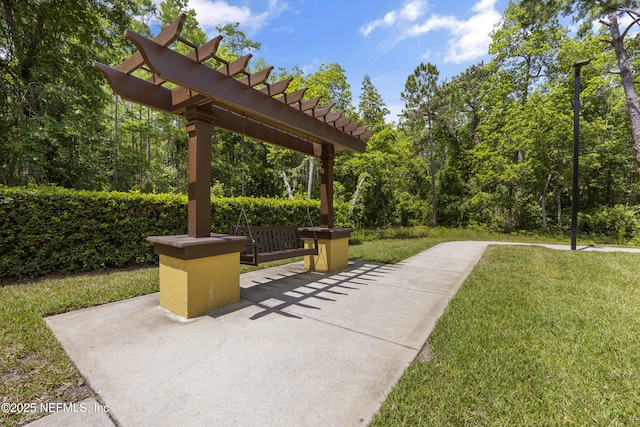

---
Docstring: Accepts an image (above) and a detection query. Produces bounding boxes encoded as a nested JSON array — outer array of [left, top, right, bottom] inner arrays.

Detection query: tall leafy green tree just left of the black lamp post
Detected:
[[474, 2, 566, 231]]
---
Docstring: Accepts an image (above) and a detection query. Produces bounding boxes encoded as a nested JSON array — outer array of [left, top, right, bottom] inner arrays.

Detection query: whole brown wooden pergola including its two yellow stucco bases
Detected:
[[93, 14, 373, 318]]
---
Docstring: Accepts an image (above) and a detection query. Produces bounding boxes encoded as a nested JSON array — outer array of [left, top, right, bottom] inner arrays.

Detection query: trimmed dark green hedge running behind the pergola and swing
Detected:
[[0, 186, 348, 278]]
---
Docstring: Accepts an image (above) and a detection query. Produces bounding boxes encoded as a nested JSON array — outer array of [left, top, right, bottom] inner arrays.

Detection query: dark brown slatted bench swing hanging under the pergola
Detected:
[[231, 225, 318, 265]]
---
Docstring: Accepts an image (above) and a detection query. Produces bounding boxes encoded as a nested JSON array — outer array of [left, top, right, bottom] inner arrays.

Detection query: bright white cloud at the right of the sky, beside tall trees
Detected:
[[406, 0, 501, 64]]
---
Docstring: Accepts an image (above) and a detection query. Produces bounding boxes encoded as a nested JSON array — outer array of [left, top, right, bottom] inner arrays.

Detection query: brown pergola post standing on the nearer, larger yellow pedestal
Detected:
[[185, 108, 214, 238]]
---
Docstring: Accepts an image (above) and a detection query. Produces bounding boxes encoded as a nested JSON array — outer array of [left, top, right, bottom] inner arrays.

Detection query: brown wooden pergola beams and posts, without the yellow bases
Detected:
[[93, 14, 373, 237]]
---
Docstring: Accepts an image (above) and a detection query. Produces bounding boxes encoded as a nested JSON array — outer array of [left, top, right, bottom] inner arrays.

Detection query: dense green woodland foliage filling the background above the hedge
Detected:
[[0, 0, 640, 241]]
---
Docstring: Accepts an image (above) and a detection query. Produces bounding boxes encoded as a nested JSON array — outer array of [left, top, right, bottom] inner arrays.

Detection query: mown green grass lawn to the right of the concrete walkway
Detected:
[[373, 247, 640, 426]]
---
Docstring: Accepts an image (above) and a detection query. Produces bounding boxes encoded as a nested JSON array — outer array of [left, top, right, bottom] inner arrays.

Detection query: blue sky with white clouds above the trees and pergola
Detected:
[[152, 0, 508, 121]]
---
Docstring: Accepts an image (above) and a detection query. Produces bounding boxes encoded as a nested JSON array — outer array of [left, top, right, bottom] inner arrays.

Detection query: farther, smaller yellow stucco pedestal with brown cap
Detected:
[[302, 228, 352, 273]]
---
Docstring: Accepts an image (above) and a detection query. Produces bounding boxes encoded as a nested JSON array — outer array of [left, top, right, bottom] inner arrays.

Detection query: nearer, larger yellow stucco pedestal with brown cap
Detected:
[[148, 234, 246, 319]]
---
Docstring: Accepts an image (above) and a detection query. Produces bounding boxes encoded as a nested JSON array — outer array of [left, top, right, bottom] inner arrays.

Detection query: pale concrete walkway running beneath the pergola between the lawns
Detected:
[[36, 242, 640, 427]]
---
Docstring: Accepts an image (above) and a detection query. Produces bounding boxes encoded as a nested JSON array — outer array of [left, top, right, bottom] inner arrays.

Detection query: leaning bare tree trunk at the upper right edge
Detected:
[[606, 11, 640, 170]]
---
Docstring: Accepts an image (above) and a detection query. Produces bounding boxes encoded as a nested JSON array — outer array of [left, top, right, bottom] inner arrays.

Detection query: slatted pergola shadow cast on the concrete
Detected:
[[228, 262, 397, 320]]
